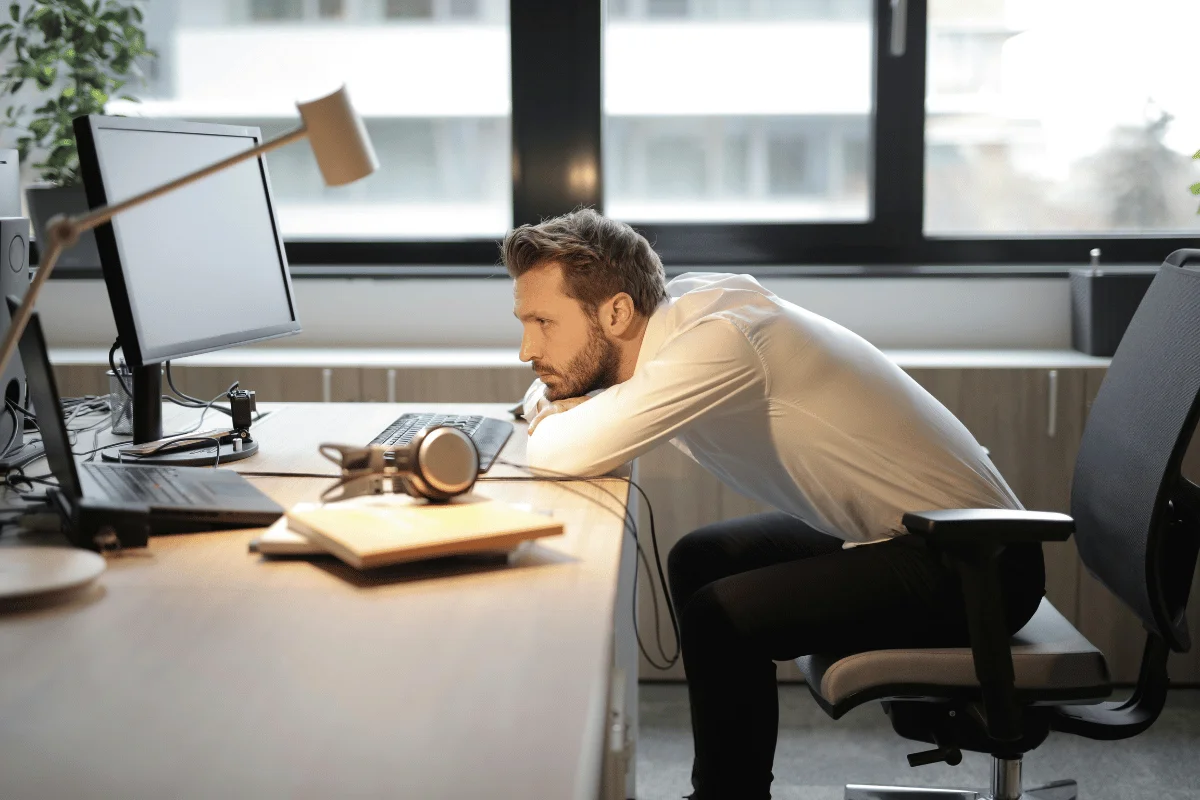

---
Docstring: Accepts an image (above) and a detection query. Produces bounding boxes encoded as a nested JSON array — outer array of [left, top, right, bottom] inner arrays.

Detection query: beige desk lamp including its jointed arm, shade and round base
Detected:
[[0, 86, 379, 599]]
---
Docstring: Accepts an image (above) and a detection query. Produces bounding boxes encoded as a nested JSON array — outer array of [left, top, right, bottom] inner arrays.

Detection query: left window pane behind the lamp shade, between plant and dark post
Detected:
[[120, 0, 512, 241]]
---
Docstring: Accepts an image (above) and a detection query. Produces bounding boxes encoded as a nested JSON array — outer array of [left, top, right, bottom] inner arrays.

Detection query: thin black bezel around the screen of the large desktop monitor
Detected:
[[74, 114, 300, 367]]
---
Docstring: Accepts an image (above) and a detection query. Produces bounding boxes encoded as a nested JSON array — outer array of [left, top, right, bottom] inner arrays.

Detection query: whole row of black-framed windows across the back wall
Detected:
[[14, 0, 1200, 270]]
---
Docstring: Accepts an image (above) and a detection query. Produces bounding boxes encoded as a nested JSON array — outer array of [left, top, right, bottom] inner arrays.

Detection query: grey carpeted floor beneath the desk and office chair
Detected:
[[637, 684, 1200, 800]]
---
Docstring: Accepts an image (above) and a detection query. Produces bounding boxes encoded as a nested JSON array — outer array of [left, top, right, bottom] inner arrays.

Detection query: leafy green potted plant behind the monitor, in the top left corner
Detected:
[[0, 0, 156, 266]]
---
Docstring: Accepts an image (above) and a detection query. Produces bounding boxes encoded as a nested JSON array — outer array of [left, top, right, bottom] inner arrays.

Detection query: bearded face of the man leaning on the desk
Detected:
[[512, 263, 620, 401]]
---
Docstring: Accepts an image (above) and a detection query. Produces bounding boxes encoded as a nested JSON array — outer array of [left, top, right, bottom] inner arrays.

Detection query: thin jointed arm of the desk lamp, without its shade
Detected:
[[0, 126, 308, 383]]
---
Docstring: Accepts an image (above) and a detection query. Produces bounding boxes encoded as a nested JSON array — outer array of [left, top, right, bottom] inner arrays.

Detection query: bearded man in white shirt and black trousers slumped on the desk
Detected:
[[503, 210, 1045, 800]]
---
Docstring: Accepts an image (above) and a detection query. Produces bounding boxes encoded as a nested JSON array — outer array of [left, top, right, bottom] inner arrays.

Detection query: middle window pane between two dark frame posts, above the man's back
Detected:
[[604, 0, 874, 223]]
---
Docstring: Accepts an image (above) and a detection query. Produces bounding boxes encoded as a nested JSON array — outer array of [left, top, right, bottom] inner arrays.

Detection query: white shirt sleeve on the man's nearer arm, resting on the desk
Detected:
[[528, 319, 767, 476]]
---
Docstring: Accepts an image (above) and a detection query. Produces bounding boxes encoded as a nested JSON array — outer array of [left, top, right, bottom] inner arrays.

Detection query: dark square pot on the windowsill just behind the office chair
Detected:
[[1069, 266, 1158, 356]]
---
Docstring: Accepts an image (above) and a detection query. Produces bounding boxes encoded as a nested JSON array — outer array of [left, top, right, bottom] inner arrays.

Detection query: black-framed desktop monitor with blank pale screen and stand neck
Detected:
[[74, 115, 300, 461]]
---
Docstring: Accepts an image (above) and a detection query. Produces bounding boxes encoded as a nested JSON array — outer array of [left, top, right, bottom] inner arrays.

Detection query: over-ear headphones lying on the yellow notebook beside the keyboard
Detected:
[[319, 425, 479, 503]]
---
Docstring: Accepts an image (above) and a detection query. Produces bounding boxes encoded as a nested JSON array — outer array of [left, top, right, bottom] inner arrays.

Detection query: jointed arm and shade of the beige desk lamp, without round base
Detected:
[[0, 86, 379, 391]]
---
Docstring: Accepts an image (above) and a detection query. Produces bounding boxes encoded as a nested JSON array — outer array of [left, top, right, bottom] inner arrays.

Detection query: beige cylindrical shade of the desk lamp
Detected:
[[296, 86, 379, 186]]
